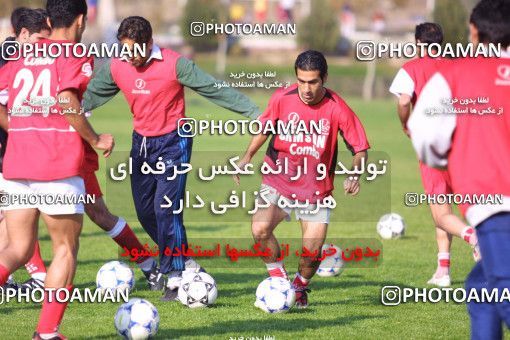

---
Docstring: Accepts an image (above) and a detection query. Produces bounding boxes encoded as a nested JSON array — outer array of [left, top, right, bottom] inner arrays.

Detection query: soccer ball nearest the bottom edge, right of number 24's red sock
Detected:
[[114, 298, 159, 340]]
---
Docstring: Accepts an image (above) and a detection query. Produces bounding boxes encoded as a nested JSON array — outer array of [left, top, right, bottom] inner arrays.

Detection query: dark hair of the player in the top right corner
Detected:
[[469, 0, 510, 47]]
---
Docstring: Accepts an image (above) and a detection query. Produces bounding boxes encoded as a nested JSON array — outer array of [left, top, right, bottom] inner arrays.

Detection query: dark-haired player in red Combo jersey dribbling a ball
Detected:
[[235, 51, 369, 308]]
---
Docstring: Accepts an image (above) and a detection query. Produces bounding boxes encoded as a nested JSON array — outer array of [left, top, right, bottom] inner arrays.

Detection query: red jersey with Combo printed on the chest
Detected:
[[259, 84, 370, 203]]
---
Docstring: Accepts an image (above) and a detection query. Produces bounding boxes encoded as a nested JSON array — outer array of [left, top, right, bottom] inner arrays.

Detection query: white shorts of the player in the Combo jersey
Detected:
[[257, 184, 331, 224]]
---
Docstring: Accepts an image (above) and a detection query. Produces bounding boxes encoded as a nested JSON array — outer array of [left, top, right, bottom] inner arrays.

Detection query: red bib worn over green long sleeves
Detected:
[[111, 49, 185, 137]]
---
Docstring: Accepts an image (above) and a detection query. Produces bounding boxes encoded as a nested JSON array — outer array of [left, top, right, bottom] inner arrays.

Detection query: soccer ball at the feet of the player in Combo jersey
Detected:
[[255, 277, 296, 313]]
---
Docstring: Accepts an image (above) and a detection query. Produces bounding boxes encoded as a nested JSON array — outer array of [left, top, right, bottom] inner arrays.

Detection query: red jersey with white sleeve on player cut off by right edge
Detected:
[[408, 53, 510, 226]]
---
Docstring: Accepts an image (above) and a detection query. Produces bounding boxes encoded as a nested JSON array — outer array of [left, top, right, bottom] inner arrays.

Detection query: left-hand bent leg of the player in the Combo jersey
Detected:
[[251, 204, 288, 279]]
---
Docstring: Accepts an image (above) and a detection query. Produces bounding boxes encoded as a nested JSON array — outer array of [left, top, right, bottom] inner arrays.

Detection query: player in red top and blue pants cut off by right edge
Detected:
[[407, 0, 510, 339]]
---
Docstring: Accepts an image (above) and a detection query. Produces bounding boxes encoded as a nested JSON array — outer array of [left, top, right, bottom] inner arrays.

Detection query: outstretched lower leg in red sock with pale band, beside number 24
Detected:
[[85, 197, 161, 290]]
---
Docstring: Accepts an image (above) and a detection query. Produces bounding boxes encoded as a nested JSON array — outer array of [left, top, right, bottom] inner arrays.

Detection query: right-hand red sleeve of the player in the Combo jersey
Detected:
[[338, 103, 370, 155]]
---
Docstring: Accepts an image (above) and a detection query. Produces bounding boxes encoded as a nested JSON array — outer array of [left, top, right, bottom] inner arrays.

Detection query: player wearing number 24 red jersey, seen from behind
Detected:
[[0, 0, 114, 339]]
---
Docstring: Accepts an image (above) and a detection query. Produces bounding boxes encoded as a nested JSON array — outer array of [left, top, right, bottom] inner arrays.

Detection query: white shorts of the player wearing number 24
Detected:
[[0, 174, 85, 215]]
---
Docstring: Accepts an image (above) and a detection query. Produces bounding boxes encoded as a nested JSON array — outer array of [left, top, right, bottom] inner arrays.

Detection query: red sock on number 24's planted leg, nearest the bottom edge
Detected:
[[37, 285, 73, 334]]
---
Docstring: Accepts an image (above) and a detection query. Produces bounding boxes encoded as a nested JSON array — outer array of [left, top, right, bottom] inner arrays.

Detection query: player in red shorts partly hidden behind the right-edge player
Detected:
[[390, 22, 479, 287]]
